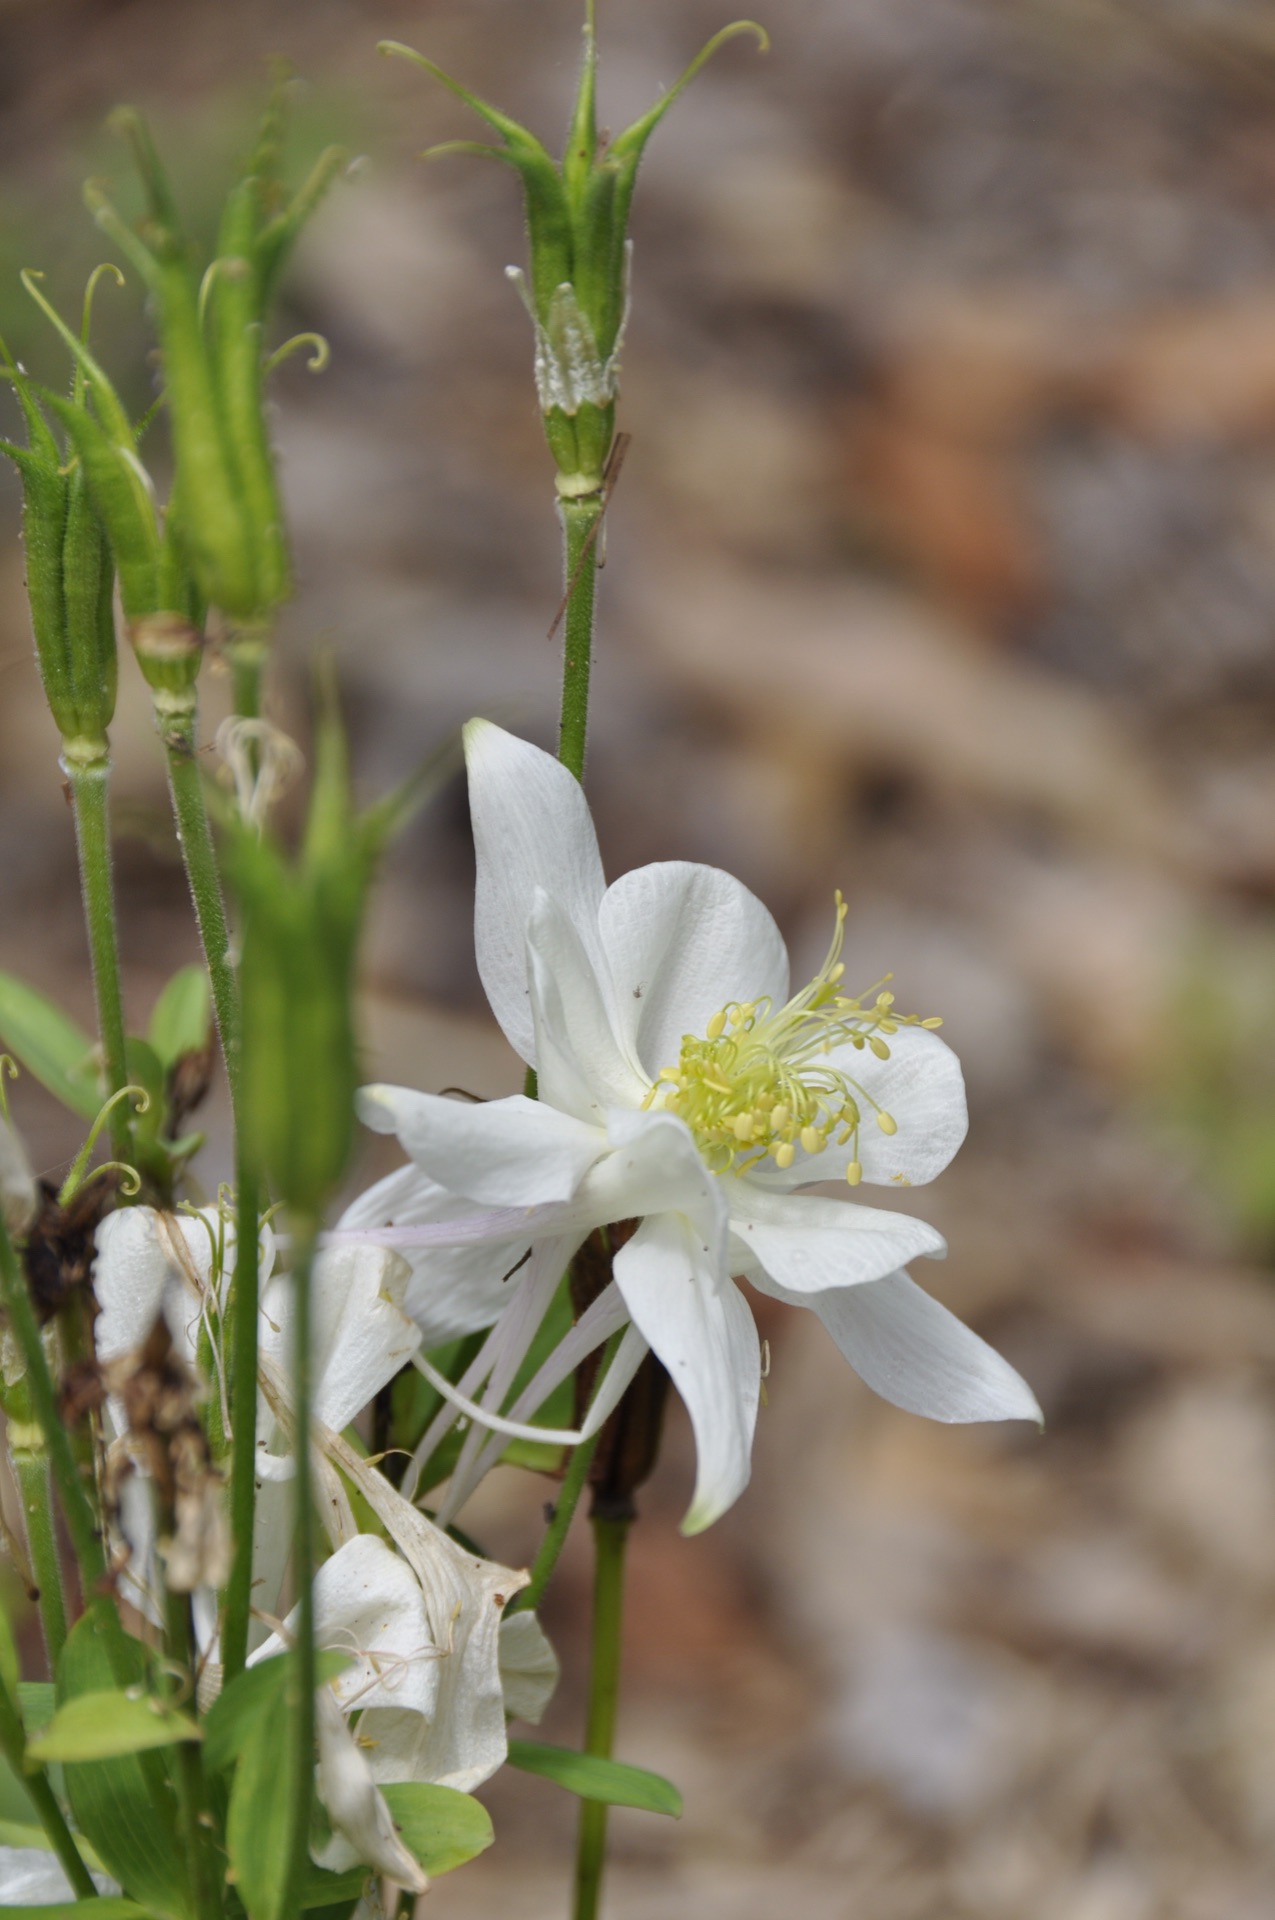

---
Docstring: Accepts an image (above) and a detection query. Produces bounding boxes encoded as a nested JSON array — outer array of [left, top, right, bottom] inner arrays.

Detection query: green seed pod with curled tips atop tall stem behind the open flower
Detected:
[[380, 0, 770, 499]]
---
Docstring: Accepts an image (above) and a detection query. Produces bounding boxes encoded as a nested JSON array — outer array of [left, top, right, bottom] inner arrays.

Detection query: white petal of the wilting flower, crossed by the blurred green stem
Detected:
[[259, 1246, 421, 1432]]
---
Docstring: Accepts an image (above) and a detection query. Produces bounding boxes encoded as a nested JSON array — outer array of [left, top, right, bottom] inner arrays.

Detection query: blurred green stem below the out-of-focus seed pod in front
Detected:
[[282, 1215, 319, 1914]]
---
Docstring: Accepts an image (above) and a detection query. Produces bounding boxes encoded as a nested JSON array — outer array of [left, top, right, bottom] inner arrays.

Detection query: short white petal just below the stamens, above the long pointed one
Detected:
[[722, 1179, 945, 1294]]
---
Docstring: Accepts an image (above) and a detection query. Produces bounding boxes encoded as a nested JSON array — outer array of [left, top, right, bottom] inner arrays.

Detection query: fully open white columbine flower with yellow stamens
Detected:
[[340, 720, 1039, 1532]]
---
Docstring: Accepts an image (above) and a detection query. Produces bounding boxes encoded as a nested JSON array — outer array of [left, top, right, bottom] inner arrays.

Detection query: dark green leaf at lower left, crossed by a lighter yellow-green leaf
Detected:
[[56, 1613, 188, 1920]]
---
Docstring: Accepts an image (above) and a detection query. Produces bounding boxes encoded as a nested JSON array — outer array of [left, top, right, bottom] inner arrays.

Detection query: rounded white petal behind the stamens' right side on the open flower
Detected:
[[764, 1027, 970, 1187]]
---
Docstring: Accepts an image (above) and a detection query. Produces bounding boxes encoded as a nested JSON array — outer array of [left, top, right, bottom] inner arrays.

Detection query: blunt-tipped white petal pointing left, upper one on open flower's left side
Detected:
[[359, 1087, 603, 1206]]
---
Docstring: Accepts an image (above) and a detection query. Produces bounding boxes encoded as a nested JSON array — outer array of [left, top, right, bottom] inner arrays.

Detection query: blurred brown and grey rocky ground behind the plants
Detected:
[[0, 0, 1275, 1920]]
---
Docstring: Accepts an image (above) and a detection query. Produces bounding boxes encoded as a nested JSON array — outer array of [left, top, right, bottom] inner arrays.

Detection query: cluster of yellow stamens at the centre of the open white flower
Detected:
[[643, 893, 941, 1187]]
